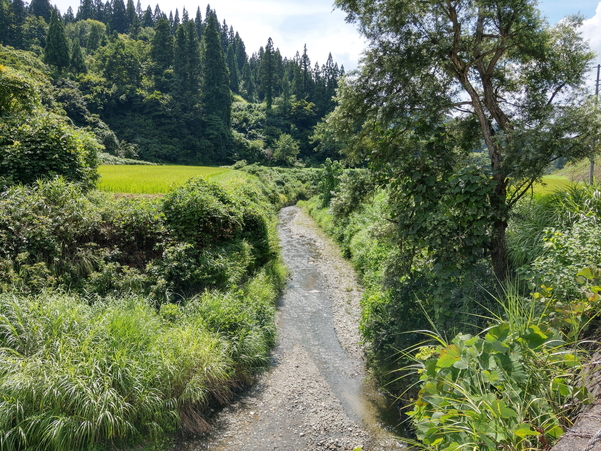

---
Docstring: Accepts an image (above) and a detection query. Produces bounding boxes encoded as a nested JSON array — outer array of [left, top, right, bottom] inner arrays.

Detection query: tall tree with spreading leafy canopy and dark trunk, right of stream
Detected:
[[329, 0, 595, 280]]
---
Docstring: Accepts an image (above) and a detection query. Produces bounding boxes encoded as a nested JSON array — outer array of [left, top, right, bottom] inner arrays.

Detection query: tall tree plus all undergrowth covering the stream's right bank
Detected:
[[298, 0, 601, 450]]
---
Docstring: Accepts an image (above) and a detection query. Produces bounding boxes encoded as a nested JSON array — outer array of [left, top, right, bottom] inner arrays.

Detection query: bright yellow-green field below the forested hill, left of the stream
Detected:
[[98, 165, 232, 194]]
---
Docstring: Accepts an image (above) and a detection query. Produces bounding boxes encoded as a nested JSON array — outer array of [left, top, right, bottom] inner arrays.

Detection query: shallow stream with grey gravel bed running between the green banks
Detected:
[[179, 207, 402, 451]]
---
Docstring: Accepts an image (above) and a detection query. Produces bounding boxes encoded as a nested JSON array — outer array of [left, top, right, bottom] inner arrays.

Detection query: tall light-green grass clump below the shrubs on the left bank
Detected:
[[0, 264, 284, 451]]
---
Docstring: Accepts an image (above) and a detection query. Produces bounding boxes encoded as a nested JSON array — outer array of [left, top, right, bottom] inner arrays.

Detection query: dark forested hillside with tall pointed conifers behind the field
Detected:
[[0, 0, 344, 165]]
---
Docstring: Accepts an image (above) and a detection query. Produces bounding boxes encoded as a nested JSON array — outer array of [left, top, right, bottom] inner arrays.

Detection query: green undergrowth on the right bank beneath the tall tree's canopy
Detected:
[[304, 167, 601, 450]]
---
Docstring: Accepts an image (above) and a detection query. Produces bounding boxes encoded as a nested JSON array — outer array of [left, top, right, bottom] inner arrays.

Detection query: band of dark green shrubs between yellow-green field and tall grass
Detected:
[[0, 179, 276, 302]]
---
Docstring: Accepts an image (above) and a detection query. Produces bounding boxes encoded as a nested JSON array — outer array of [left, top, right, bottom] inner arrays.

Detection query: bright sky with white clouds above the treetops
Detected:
[[51, 0, 601, 70]]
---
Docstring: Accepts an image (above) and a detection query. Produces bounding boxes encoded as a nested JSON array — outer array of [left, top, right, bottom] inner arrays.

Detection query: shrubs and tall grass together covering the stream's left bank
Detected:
[[0, 169, 317, 450]]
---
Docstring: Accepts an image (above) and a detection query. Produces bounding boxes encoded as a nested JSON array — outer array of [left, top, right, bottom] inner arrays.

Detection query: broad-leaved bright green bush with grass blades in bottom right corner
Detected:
[[409, 293, 587, 450]]
